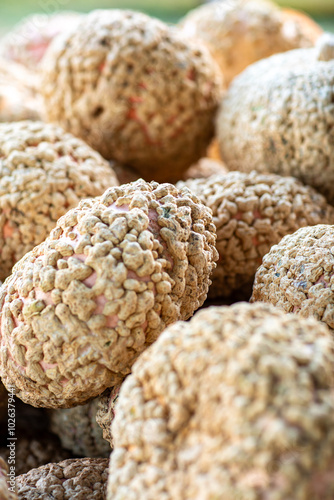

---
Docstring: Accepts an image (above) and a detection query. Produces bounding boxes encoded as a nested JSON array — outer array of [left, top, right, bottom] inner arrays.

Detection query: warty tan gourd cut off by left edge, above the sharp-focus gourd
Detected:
[[0, 121, 118, 279]]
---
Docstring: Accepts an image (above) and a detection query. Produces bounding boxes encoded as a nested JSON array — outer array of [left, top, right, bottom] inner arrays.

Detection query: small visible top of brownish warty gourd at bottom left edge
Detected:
[[16, 458, 108, 500]]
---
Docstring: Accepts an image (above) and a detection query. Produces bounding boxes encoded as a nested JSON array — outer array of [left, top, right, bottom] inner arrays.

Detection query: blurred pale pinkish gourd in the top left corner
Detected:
[[0, 11, 82, 72]]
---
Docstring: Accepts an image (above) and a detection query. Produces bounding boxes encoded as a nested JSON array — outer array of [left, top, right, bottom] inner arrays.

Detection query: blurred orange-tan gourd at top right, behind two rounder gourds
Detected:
[[180, 0, 322, 85]]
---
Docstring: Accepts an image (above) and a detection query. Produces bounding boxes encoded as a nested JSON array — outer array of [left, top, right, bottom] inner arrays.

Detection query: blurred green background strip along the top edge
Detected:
[[0, 0, 334, 32]]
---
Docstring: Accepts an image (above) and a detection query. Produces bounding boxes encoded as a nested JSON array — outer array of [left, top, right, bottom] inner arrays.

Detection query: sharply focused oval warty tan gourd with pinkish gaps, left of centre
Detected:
[[0, 180, 218, 408]]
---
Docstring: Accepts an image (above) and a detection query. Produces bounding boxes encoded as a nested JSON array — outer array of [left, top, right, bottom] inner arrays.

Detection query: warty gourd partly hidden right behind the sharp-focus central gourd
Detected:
[[177, 171, 334, 297]]
